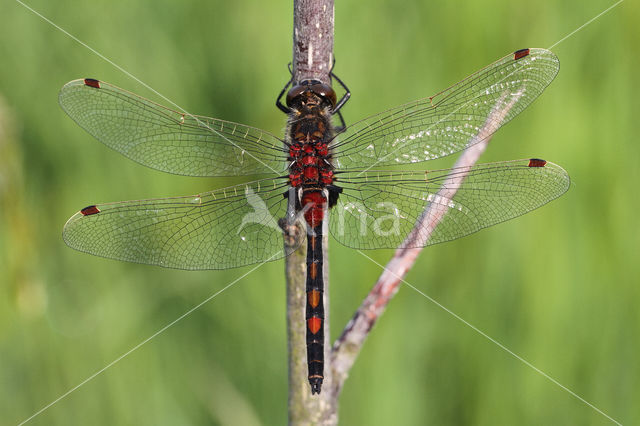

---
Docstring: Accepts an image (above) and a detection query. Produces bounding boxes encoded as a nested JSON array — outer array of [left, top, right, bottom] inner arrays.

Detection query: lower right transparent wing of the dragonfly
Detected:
[[329, 159, 570, 249]]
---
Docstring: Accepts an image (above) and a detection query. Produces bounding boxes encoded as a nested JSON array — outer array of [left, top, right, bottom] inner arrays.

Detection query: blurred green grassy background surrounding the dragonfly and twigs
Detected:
[[0, 0, 640, 425]]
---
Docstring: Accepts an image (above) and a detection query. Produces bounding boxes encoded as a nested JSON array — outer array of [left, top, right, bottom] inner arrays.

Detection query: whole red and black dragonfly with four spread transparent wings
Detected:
[[59, 48, 570, 394]]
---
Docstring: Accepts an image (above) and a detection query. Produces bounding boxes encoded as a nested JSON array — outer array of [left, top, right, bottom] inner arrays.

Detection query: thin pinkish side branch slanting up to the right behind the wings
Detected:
[[328, 90, 518, 395]]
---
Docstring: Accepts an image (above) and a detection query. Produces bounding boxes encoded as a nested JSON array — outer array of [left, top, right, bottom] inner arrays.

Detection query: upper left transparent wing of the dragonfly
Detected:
[[59, 79, 287, 176]]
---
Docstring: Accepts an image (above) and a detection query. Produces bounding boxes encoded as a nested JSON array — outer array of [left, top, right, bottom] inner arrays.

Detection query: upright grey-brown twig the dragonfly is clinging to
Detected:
[[283, 0, 337, 425]]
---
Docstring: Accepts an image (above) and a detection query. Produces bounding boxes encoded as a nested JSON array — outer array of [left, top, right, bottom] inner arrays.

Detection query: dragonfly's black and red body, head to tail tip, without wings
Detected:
[[287, 80, 338, 394]]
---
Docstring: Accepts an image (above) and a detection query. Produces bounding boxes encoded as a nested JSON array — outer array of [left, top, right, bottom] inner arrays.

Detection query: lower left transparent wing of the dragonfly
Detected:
[[62, 179, 288, 269]]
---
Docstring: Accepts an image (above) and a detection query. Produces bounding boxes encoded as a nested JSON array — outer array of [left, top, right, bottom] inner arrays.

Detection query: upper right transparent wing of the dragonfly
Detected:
[[332, 49, 560, 169]]
